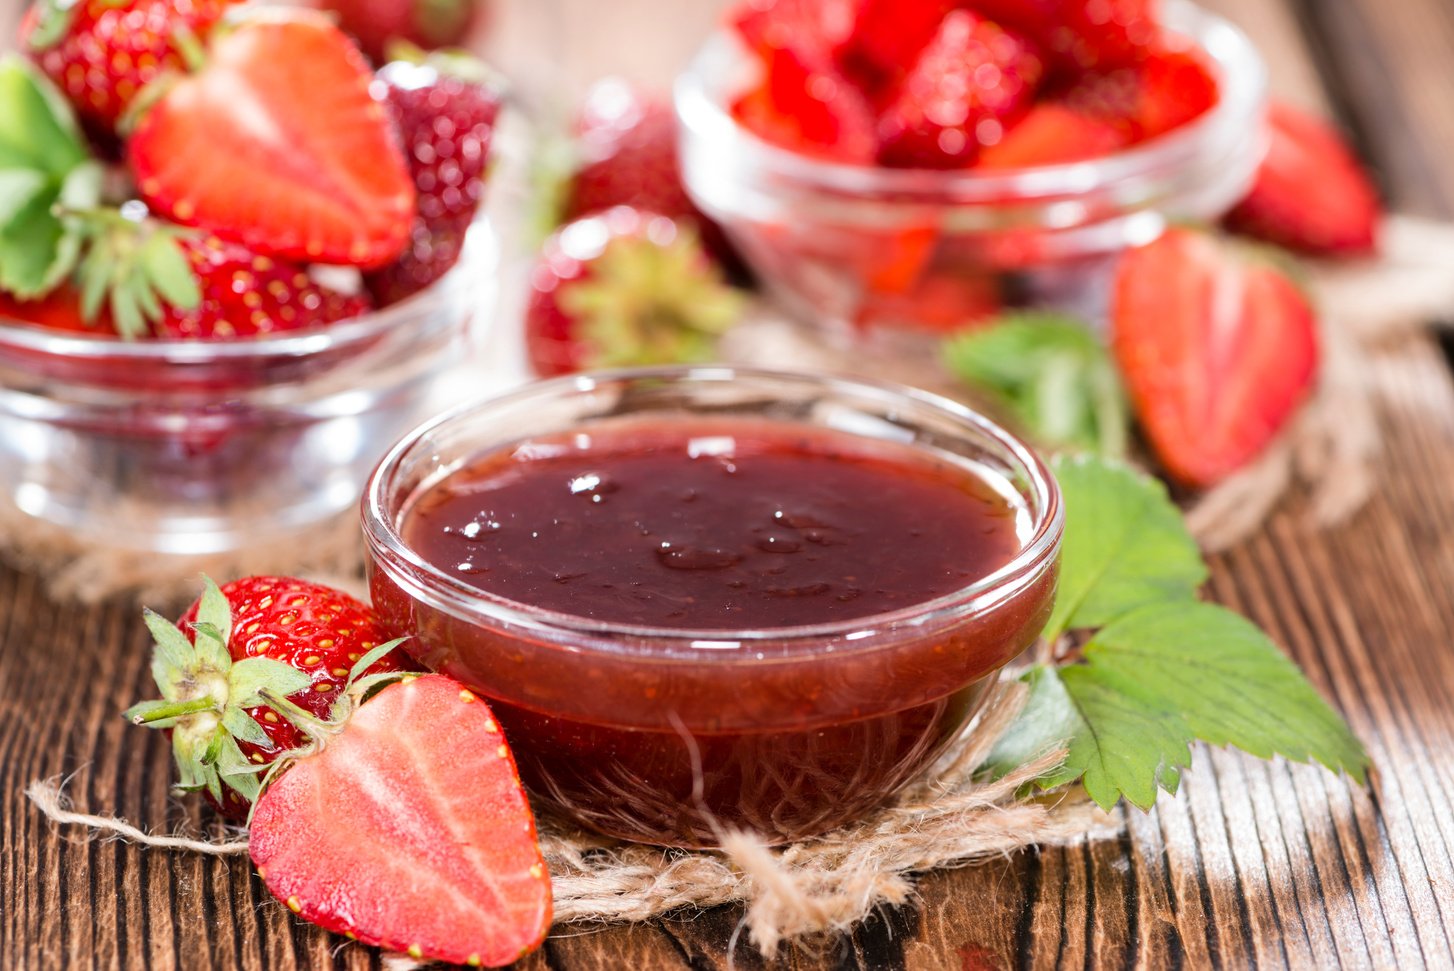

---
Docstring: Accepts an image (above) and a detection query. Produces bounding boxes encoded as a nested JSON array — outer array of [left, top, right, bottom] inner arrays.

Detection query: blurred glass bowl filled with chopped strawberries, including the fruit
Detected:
[[675, 0, 1266, 347]]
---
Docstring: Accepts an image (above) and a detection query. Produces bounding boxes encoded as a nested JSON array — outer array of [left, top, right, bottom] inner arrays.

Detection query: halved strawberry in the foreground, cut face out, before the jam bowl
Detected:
[[249, 674, 551, 968]]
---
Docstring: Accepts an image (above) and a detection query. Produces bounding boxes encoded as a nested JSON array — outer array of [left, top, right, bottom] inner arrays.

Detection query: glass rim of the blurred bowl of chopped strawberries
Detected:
[[672, 0, 1268, 205]]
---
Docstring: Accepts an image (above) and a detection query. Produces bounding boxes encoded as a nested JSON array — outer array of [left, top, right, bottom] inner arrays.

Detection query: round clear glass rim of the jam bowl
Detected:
[[361, 365, 1064, 660]]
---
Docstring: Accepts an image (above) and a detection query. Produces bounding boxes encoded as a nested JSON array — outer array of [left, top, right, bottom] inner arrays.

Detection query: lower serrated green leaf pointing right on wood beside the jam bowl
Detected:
[[986, 603, 1368, 810]]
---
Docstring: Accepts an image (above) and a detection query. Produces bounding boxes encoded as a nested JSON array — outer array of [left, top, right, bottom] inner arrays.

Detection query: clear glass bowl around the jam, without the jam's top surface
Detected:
[[362, 366, 1064, 846]]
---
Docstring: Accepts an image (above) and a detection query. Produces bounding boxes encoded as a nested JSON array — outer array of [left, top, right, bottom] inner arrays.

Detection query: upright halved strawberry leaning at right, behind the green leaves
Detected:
[[1111, 228, 1317, 487]]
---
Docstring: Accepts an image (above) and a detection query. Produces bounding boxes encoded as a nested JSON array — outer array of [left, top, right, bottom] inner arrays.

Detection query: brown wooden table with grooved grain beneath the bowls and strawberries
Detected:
[[0, 0, 1454, 971]]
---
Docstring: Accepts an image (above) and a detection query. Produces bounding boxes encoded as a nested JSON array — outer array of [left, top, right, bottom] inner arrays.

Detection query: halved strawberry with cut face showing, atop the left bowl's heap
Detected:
[[126, 7, 414, 267]]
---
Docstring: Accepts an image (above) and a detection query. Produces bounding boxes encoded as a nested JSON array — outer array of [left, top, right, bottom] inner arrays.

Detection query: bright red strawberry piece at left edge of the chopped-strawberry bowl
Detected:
[[731, 47, 878, 163]]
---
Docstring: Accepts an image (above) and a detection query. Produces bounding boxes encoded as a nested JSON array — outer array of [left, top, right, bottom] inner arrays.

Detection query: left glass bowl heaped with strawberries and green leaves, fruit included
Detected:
[[0, 0, 500, 554]]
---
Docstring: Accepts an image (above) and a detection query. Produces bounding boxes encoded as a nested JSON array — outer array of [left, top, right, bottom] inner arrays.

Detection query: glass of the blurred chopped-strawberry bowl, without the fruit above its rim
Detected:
[[675, 3, 1266, 346]]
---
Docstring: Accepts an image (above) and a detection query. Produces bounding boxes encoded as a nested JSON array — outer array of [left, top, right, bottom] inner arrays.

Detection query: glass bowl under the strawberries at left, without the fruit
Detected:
[[0, 222, 496, 554]]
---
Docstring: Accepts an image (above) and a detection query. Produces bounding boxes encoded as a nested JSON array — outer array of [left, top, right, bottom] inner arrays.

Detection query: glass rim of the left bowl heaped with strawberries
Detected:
[[0, 215, 499, 366]]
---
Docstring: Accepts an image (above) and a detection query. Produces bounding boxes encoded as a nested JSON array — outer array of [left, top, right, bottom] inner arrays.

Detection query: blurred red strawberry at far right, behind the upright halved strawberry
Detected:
[[1227, 102, 1383, 256]]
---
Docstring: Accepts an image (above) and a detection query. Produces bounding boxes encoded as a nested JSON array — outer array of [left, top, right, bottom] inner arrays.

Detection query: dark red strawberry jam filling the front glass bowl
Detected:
[[365, 398, 1060, 846]]
